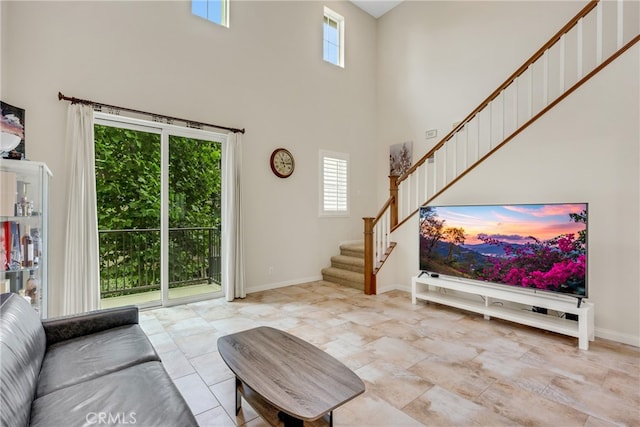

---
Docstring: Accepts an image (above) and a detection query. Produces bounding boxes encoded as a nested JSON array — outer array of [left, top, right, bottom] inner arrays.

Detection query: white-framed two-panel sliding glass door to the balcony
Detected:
[[95, 113, 225, 307]]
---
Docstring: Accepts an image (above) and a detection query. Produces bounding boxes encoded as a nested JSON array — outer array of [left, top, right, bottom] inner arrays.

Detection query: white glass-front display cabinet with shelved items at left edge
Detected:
[[0, 159, 51, 318]]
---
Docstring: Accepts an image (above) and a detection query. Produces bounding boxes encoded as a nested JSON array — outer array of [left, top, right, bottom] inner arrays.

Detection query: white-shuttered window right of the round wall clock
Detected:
[[318, 150, 351, 217]]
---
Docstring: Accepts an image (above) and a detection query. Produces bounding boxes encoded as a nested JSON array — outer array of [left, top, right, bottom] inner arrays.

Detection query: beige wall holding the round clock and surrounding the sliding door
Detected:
[[0, 1, 377, 314]]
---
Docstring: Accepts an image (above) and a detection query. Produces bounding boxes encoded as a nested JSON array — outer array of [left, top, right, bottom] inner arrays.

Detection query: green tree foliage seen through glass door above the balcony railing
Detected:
[[95, 125, 222, 230]]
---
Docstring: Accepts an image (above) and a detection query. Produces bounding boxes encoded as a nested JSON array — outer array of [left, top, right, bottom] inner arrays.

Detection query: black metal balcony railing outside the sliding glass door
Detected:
[[98, 227, 221, 298]]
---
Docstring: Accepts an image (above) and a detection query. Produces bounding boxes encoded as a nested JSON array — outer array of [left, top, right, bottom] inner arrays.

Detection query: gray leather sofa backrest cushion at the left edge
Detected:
[[0, 294, 46, 426]]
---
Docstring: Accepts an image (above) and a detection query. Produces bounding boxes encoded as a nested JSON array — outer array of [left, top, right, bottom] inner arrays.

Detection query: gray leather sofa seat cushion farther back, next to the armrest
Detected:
[[36, 324, 160, 397]]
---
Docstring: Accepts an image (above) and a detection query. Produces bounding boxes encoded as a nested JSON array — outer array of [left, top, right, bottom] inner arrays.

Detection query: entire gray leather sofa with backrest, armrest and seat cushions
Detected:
[[0, 294, 197, 427]]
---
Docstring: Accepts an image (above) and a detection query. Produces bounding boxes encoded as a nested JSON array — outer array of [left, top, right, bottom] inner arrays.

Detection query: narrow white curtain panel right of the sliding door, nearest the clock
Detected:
[[222, 132, 246, 301]]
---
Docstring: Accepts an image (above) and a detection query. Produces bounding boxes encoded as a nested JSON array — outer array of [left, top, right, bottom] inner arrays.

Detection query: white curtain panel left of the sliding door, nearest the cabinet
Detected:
[[62, 104, 100, 314]]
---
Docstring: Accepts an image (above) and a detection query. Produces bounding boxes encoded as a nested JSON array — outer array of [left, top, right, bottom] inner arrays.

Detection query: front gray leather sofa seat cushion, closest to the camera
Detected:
[[31, 362, 197, 427]]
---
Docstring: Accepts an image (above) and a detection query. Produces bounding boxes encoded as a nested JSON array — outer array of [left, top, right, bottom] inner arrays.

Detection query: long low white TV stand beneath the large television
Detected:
[[411, 274, 595, 350]]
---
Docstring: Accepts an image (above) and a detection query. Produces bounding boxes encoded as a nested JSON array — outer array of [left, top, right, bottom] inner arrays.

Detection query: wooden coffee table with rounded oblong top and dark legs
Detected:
[[218, 326, 364, 427]]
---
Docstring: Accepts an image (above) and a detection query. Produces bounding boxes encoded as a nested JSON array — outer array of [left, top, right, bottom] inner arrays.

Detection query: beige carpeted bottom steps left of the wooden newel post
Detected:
[[322, 242, 364, 291]]
